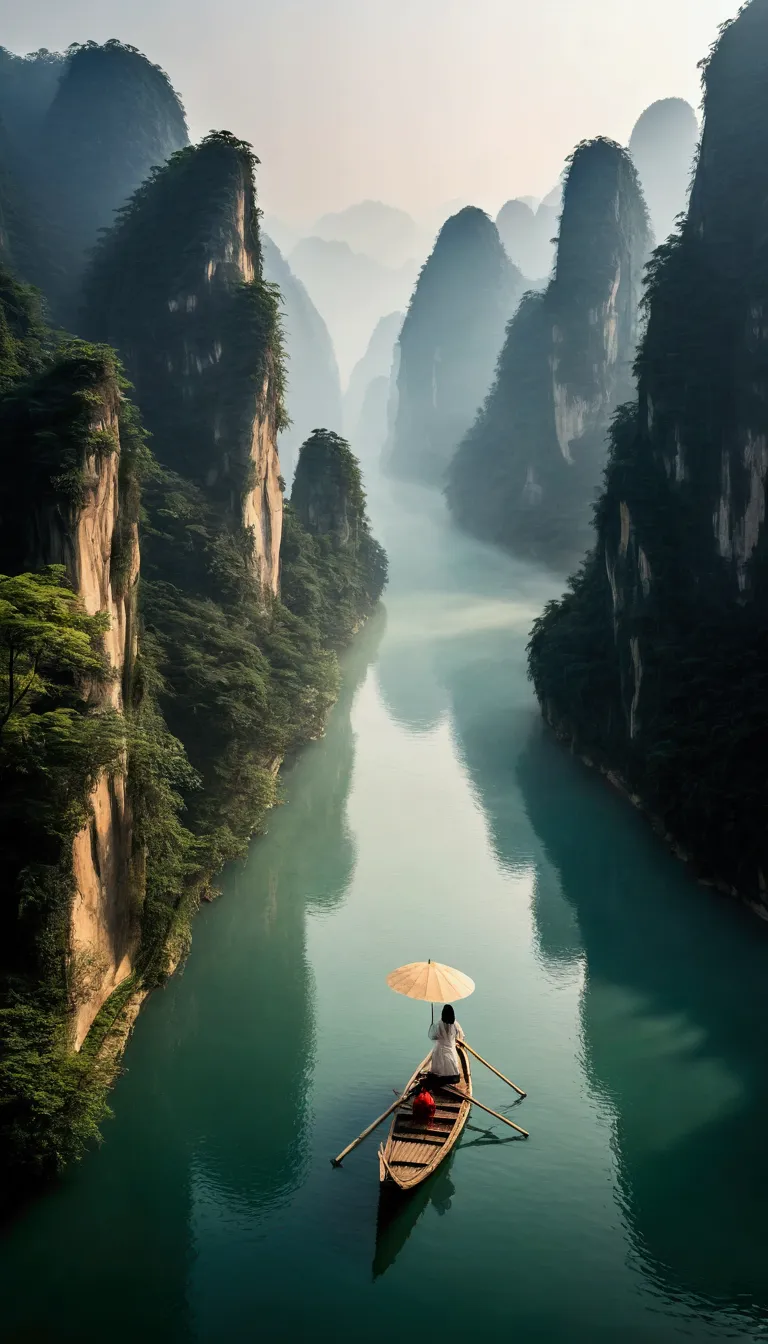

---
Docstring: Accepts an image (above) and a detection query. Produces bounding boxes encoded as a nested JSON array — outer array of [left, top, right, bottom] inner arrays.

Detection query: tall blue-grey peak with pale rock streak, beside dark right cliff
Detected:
[[447, 140, 650, 562]]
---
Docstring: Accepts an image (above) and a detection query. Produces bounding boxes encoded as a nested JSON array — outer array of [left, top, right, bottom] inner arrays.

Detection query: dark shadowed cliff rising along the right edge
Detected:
[[531, 0, 768, 906]]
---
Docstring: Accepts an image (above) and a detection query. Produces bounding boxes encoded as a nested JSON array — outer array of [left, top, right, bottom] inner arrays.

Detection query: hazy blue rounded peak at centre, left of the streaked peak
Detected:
[[386, 206, 523, 485]]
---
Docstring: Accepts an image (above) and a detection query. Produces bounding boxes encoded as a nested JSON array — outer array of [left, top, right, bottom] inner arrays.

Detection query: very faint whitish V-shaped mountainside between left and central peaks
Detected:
[[288, 238, 418, 386]]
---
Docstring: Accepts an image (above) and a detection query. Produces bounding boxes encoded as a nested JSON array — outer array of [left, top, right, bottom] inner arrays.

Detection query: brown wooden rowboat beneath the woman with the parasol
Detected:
[[379, 1042, 472, 1193]]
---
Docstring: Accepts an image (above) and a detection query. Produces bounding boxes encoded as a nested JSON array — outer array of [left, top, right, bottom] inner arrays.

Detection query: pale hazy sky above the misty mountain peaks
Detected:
[[0, 0, 738, 223]]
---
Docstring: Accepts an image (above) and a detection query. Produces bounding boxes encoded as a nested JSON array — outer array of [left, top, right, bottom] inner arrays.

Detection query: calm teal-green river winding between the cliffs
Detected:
[[0, 487, 768, 1344]]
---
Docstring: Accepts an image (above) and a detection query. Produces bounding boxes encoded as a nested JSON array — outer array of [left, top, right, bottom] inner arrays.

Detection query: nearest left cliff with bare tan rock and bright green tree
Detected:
[[0, 264, 192, 1198]]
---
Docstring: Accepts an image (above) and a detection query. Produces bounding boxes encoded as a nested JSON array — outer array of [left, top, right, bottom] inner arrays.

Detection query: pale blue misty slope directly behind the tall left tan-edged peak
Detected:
[[261, 233, 342, 481]]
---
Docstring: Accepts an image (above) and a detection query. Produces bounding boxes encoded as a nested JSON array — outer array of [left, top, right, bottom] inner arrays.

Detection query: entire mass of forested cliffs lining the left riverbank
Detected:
[[0, 52, 386, 1191]]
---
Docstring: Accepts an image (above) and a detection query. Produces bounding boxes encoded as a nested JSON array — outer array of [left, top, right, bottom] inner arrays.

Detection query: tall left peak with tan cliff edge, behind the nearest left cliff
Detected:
[[86, 132, 390, 867]]
